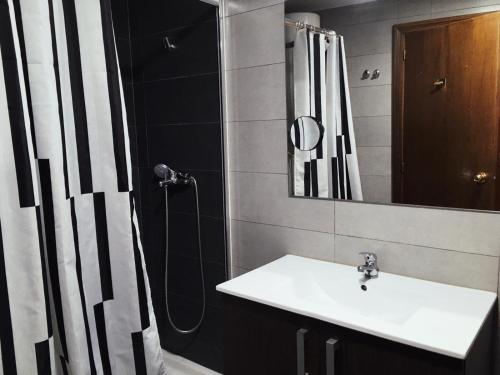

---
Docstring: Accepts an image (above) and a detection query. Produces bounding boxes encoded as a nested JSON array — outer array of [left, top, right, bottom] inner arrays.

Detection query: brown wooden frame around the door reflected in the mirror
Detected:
[[391, 11, 500, 206]]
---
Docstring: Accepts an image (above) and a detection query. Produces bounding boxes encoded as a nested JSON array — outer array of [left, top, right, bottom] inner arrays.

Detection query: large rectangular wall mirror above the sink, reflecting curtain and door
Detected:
[[284, 0, 500, 211]]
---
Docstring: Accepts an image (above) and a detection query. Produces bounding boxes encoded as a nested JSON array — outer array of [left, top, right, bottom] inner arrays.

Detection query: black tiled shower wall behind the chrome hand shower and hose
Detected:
[[112, 0, 227, 372]]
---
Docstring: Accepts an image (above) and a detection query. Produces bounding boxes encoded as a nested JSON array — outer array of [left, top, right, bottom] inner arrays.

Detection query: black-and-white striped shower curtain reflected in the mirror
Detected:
[[288, 29, 363, 200]]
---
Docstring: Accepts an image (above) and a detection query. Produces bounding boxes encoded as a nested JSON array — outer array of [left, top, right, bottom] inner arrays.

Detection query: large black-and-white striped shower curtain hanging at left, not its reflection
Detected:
[[0, 0, 165, 375]]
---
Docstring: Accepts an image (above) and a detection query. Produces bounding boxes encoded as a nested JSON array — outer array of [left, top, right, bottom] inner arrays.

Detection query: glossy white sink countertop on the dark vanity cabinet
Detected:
[[217, 255, 497, 359]]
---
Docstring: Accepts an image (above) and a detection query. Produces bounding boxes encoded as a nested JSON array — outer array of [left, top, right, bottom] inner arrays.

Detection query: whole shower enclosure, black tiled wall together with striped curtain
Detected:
[[0, 0, 227, 375]]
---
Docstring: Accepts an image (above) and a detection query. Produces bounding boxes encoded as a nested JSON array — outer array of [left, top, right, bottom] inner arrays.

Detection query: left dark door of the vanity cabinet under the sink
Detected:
[[224, 296, 318, 375]]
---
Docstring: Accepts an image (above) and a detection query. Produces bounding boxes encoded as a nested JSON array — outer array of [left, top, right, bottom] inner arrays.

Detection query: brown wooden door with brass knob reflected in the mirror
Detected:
[[393, 12, 500, 210]]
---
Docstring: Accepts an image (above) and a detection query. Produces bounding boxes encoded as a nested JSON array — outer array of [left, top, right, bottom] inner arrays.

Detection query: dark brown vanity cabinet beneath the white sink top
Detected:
[[223, 295, 495, 375]]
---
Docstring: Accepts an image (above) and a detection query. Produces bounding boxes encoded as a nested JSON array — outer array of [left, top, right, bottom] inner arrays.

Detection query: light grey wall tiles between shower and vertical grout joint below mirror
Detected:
[[223, 0, 335, 275]]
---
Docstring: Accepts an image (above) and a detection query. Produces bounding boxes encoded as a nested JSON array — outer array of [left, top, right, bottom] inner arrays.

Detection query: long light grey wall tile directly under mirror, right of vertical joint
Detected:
[[335, 201, 500, 257]]
